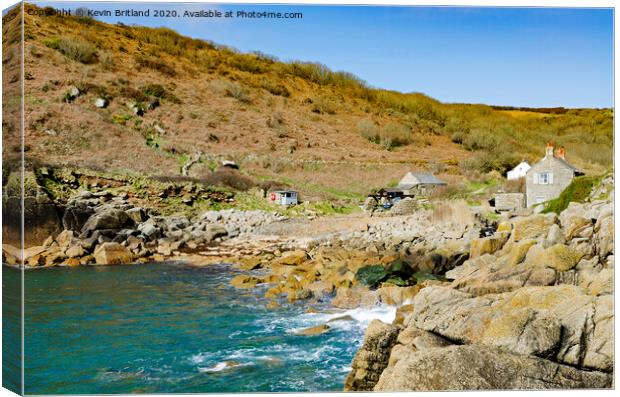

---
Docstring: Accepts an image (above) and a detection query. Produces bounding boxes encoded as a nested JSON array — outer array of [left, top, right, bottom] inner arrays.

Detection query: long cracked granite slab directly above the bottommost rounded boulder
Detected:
[[408, 284, 613, 372]]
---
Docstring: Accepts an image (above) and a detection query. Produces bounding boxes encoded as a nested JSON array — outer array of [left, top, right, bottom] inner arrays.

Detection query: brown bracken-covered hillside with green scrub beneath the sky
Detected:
[[3, 5, 613, 200]]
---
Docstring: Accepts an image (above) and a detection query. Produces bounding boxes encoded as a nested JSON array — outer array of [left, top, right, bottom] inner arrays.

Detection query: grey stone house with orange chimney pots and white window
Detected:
[[525, 142, 583, 207]]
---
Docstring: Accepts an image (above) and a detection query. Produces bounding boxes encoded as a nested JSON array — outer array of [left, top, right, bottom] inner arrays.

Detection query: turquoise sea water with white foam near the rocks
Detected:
[[3, 264, 394, 394]]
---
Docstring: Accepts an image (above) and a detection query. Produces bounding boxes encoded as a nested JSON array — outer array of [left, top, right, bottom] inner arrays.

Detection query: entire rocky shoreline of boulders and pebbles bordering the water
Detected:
[[3, 170, 614, 391]]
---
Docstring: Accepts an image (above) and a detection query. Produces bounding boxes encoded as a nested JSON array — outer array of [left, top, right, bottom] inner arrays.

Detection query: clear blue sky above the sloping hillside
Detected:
[[34, 2, 613, 107]]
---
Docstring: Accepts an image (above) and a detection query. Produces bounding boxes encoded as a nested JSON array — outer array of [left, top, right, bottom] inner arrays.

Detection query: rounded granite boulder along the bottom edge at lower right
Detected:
[[374, 345, 612, 391]]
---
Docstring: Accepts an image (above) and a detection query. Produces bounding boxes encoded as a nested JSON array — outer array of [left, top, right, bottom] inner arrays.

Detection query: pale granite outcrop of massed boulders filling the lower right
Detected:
[[345, 178, 614, 391]]
